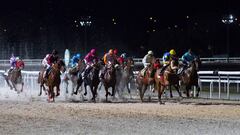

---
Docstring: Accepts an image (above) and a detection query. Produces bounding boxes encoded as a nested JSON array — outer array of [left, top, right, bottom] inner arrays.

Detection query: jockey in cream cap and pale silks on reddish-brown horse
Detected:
[[141, 50, 155, 76]]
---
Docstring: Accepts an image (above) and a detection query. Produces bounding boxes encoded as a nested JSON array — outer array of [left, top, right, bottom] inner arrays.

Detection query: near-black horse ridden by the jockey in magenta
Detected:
[[83, 61, 101, 102]]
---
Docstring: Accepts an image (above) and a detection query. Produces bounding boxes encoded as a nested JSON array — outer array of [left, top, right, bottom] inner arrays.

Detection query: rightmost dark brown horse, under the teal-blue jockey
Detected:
[[180, 58, 201, 97]]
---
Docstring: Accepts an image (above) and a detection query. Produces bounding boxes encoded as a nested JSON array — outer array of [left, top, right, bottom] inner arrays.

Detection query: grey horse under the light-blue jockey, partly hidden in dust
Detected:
[[63, 60, 85, 95]]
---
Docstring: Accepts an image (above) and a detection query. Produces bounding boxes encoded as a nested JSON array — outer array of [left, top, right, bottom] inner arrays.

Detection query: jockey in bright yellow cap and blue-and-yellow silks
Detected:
[[160, 49, 178, 75]]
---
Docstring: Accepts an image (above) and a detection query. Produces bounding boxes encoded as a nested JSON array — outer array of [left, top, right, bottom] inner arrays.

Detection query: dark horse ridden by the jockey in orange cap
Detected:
[[102, 63, 117, 102]]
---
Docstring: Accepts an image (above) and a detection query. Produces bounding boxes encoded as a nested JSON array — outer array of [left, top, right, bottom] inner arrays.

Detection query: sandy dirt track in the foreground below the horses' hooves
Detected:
[[0, 101, 240, 135]]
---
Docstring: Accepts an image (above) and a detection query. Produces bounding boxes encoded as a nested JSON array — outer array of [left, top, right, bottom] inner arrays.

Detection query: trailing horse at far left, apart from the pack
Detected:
[[2, 69, 24, 92]]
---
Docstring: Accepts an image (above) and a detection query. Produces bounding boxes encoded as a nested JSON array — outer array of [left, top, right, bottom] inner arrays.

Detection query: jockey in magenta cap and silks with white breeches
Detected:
[[82, 49, 98, 79]]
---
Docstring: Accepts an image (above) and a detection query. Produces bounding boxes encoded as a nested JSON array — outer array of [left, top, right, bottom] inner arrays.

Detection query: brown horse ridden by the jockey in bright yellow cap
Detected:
[[157, 60, 182, 98]]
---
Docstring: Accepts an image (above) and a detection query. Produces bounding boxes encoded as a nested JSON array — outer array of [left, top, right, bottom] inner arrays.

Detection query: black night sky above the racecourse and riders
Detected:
[[0, 0, 240, 59]]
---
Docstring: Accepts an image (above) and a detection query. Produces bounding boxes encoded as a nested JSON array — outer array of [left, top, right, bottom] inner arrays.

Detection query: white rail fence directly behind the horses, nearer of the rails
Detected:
[[0, 70, 240, 100]]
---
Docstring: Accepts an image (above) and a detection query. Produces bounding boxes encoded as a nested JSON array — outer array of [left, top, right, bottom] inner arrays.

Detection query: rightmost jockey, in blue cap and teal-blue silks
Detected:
[[182, 49, 197, 69]]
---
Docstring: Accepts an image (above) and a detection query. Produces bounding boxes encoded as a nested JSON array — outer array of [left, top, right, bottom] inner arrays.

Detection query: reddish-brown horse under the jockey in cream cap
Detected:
[[136, 64, 154, 102]]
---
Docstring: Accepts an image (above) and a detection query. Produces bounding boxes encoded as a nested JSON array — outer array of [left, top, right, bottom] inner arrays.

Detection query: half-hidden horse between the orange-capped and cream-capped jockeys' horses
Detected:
[[116, 58, 134, 98]]
